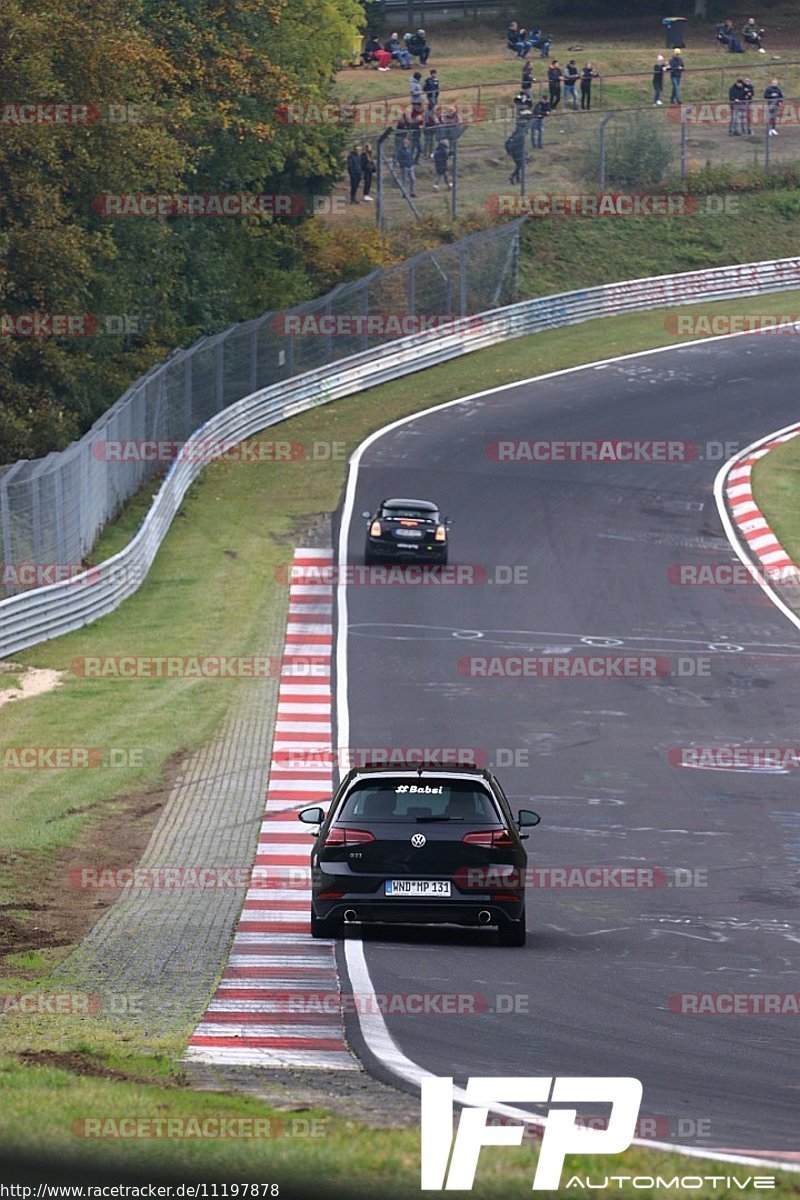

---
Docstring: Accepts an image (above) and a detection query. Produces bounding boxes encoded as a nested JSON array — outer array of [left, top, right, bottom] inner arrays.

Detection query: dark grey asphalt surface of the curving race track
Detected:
[[339, 336, 800, 1152]]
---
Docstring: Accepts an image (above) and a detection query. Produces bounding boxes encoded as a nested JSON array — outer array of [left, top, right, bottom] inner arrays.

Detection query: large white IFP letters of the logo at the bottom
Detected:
[[420, 1075, 642, 1192]]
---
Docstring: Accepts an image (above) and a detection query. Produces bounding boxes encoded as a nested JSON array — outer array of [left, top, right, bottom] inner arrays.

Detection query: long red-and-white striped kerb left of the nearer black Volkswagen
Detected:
[[185, 550, 361, 1070]]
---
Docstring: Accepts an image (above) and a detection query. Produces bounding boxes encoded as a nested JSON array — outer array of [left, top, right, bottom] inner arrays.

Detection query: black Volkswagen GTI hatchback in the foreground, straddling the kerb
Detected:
[[297, 767, 540, 946]]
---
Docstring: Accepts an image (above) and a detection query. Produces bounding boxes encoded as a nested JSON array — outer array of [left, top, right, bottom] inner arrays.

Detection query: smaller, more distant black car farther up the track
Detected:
[[361, 499, 451, 565]]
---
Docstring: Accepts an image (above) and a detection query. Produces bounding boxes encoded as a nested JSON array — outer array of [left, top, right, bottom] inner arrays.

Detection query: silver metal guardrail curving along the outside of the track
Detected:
[[0, 258, 800, 658]]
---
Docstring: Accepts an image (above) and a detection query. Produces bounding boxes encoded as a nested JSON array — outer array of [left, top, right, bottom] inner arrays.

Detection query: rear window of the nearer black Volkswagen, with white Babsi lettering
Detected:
[[335, 779, 500, 824]]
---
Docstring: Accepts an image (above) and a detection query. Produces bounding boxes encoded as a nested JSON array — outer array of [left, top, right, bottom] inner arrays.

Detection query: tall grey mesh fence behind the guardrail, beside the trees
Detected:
[[0, 221, 522, 595]]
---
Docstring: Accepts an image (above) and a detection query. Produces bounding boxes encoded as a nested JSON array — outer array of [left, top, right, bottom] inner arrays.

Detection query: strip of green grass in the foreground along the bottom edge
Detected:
[[0, 1057, 800, 1200]]
